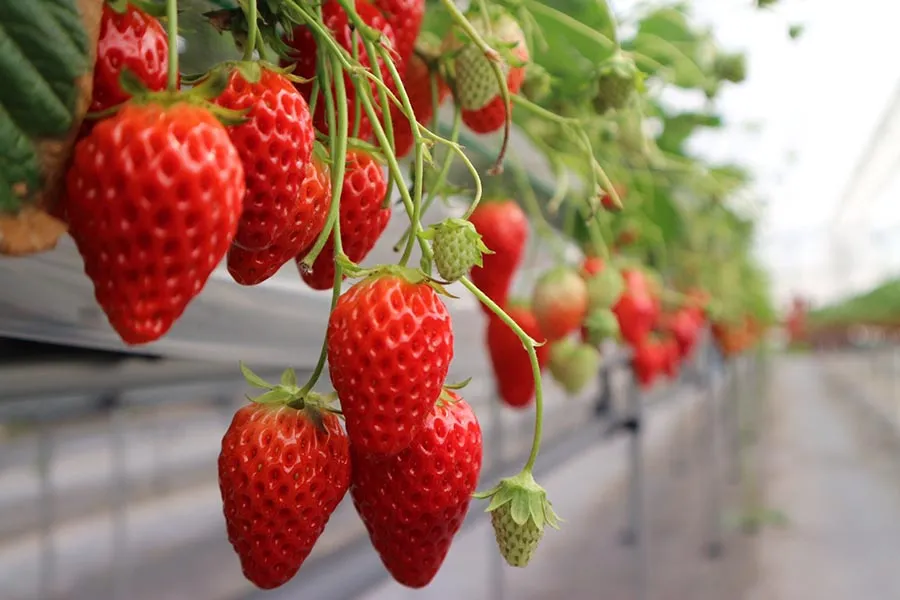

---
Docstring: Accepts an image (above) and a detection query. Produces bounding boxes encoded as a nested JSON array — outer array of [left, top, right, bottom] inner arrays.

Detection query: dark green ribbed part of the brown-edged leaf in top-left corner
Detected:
[[0, 0, 90, 212]]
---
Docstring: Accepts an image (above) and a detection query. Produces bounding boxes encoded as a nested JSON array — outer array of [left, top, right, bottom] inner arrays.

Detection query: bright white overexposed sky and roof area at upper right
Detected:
[[613, 0, 900, 303]]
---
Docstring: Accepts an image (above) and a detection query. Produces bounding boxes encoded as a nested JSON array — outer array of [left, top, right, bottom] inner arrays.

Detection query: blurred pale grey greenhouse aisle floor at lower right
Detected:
[[748, 357, 900, 600]]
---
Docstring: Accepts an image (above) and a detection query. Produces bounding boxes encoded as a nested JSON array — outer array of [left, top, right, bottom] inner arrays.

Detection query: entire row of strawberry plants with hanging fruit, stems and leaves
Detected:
[[0, 0, 771, 589]]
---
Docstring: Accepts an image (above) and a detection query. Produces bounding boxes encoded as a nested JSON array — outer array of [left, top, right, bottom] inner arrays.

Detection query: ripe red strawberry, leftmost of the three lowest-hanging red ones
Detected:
[[219, 403, 350, 589]]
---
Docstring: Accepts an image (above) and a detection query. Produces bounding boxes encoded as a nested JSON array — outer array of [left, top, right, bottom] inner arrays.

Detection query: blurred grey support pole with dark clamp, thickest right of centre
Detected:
[[622, 377, 647, 600]]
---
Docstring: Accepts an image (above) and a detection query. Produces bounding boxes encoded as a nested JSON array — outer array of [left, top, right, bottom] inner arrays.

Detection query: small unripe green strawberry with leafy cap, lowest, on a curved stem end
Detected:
[[475, 470, 559, 567]]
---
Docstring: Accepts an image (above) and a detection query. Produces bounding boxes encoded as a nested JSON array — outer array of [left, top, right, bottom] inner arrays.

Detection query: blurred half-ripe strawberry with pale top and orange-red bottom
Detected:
[[532, 266, 588, 341]]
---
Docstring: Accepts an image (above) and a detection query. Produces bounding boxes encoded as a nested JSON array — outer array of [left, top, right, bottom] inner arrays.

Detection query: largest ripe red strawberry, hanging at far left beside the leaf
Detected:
[[65, 103, 244, 344]]
